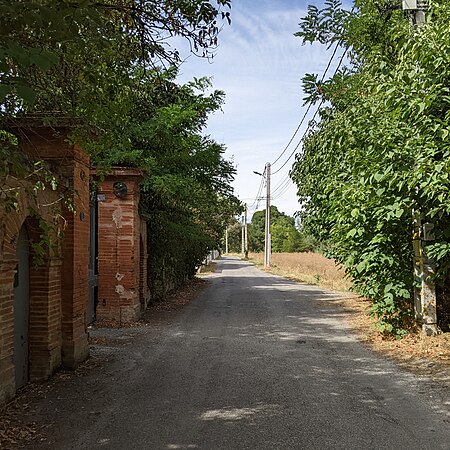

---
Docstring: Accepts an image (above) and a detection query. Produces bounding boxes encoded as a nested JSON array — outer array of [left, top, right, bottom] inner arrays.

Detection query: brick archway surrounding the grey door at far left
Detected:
[[0, 209, 61, 399]]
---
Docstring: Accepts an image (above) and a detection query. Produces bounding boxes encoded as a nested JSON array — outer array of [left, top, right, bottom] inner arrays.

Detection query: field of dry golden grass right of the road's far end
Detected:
[[249, 253, 352, 292]]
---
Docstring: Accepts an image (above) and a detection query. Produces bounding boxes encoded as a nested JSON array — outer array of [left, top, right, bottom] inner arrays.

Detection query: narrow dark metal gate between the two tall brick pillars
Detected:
[[87, 192, 98, 323]]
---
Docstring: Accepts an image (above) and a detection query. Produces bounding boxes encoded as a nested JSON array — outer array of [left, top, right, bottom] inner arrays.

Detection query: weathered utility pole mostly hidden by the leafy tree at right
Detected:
[[403, 0, 438, 336]]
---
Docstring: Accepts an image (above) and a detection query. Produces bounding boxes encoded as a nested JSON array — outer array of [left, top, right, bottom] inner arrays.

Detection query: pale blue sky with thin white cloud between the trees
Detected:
[[179, 0, 348, 216]]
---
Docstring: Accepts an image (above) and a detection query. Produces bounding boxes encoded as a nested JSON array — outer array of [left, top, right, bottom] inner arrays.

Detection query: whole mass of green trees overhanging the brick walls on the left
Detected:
[[0, 0, 239, 295]]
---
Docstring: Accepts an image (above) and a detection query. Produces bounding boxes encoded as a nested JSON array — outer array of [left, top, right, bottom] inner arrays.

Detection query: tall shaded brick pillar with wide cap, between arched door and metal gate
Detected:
[[18, 126, 89, 368]]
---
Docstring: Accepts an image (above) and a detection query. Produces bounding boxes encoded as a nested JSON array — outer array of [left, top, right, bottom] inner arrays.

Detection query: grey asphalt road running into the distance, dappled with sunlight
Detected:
[[30, 258, 450, 450]]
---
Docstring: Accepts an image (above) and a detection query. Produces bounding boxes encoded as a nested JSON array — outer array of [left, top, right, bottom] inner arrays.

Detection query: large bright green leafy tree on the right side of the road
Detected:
[[293, 0, 450, 334]]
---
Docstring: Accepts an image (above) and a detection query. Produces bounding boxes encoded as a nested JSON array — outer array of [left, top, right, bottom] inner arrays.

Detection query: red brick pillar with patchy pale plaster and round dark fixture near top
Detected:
[[97, 168, 142, 324]]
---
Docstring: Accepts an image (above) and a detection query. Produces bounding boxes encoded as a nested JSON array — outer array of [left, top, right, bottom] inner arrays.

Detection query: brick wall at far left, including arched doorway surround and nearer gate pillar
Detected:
[[0, 124, 89, 402]]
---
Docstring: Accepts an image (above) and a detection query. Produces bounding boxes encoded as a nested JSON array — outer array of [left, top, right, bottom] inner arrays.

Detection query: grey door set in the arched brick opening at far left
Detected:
[[14, 225, 30, 389]]
